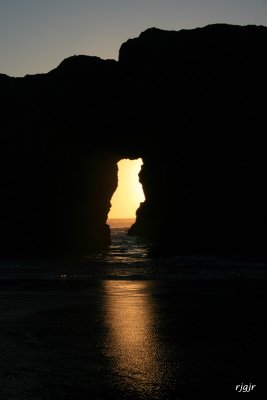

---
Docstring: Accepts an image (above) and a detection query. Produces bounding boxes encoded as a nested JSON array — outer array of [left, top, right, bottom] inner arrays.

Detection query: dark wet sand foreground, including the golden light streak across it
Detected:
[[0, 279, 267, 400]]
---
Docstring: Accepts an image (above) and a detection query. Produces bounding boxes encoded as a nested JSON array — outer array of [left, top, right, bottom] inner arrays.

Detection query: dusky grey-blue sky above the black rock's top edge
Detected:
[[0, 0, 267, 76]]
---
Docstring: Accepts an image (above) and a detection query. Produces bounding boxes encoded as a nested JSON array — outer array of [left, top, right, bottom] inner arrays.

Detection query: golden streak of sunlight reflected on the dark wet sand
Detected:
[[104, 281, 173, 398]]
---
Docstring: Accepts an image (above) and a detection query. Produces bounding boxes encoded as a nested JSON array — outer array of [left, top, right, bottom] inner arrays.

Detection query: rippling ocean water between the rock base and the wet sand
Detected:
[[0, 219, 267, 280]]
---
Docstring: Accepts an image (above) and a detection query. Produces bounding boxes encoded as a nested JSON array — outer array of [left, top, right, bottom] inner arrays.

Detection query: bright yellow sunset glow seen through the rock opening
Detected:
[[108, 158, 145, 219]]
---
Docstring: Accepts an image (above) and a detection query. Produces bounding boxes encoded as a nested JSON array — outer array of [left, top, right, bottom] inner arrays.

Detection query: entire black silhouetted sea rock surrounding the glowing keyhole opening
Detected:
[[0, 24, 267, 255]]
